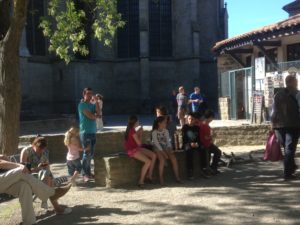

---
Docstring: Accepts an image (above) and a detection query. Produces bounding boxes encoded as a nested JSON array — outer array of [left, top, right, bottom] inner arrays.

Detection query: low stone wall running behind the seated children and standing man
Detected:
[[20, 125, 269, 162]]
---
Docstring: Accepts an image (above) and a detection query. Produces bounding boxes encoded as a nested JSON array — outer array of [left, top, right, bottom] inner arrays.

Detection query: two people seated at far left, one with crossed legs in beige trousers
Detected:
[[0, 136, 72, 225]]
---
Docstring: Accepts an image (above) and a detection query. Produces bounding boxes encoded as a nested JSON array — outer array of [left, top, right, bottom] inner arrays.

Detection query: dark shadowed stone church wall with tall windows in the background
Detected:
[[20, 0, 227, 114]]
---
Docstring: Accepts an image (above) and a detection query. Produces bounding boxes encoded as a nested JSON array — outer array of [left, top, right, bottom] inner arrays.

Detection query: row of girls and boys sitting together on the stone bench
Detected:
[[124, 106, 221, 187]]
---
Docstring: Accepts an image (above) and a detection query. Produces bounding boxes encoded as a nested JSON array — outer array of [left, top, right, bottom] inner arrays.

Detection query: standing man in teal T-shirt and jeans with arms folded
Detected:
[[78, 88, 100, 182]]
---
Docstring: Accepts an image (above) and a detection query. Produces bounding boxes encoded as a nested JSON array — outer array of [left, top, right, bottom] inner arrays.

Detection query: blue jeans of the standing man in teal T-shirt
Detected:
[[80, 133, 96, 176]]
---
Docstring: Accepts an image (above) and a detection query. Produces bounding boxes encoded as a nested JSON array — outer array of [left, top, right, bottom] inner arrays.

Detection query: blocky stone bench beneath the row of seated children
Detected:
[[94, 151, 205, 188]]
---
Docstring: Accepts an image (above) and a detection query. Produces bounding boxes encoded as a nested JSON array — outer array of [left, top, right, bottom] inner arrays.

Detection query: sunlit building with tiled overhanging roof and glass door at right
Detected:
[[212, 0, 300, 120]]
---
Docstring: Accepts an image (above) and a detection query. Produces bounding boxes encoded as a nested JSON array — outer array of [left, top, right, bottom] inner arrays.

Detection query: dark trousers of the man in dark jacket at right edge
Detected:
[[275, 128, 299, 176]]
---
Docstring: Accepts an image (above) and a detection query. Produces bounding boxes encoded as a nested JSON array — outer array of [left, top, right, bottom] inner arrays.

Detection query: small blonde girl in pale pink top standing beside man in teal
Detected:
[[64, 127, 89, 185]]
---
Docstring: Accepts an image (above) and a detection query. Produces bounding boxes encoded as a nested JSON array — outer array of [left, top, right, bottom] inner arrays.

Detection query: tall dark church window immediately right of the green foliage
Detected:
[[117, 0, 140, 58]]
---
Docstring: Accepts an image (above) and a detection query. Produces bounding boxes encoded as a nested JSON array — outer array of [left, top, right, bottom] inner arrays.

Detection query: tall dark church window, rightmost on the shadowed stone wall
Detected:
[[149, 0, 172, 57]]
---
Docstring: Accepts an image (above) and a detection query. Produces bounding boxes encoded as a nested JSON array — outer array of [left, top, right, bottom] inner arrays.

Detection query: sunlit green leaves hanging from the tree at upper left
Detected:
[[40, 0, 125, 63]]
